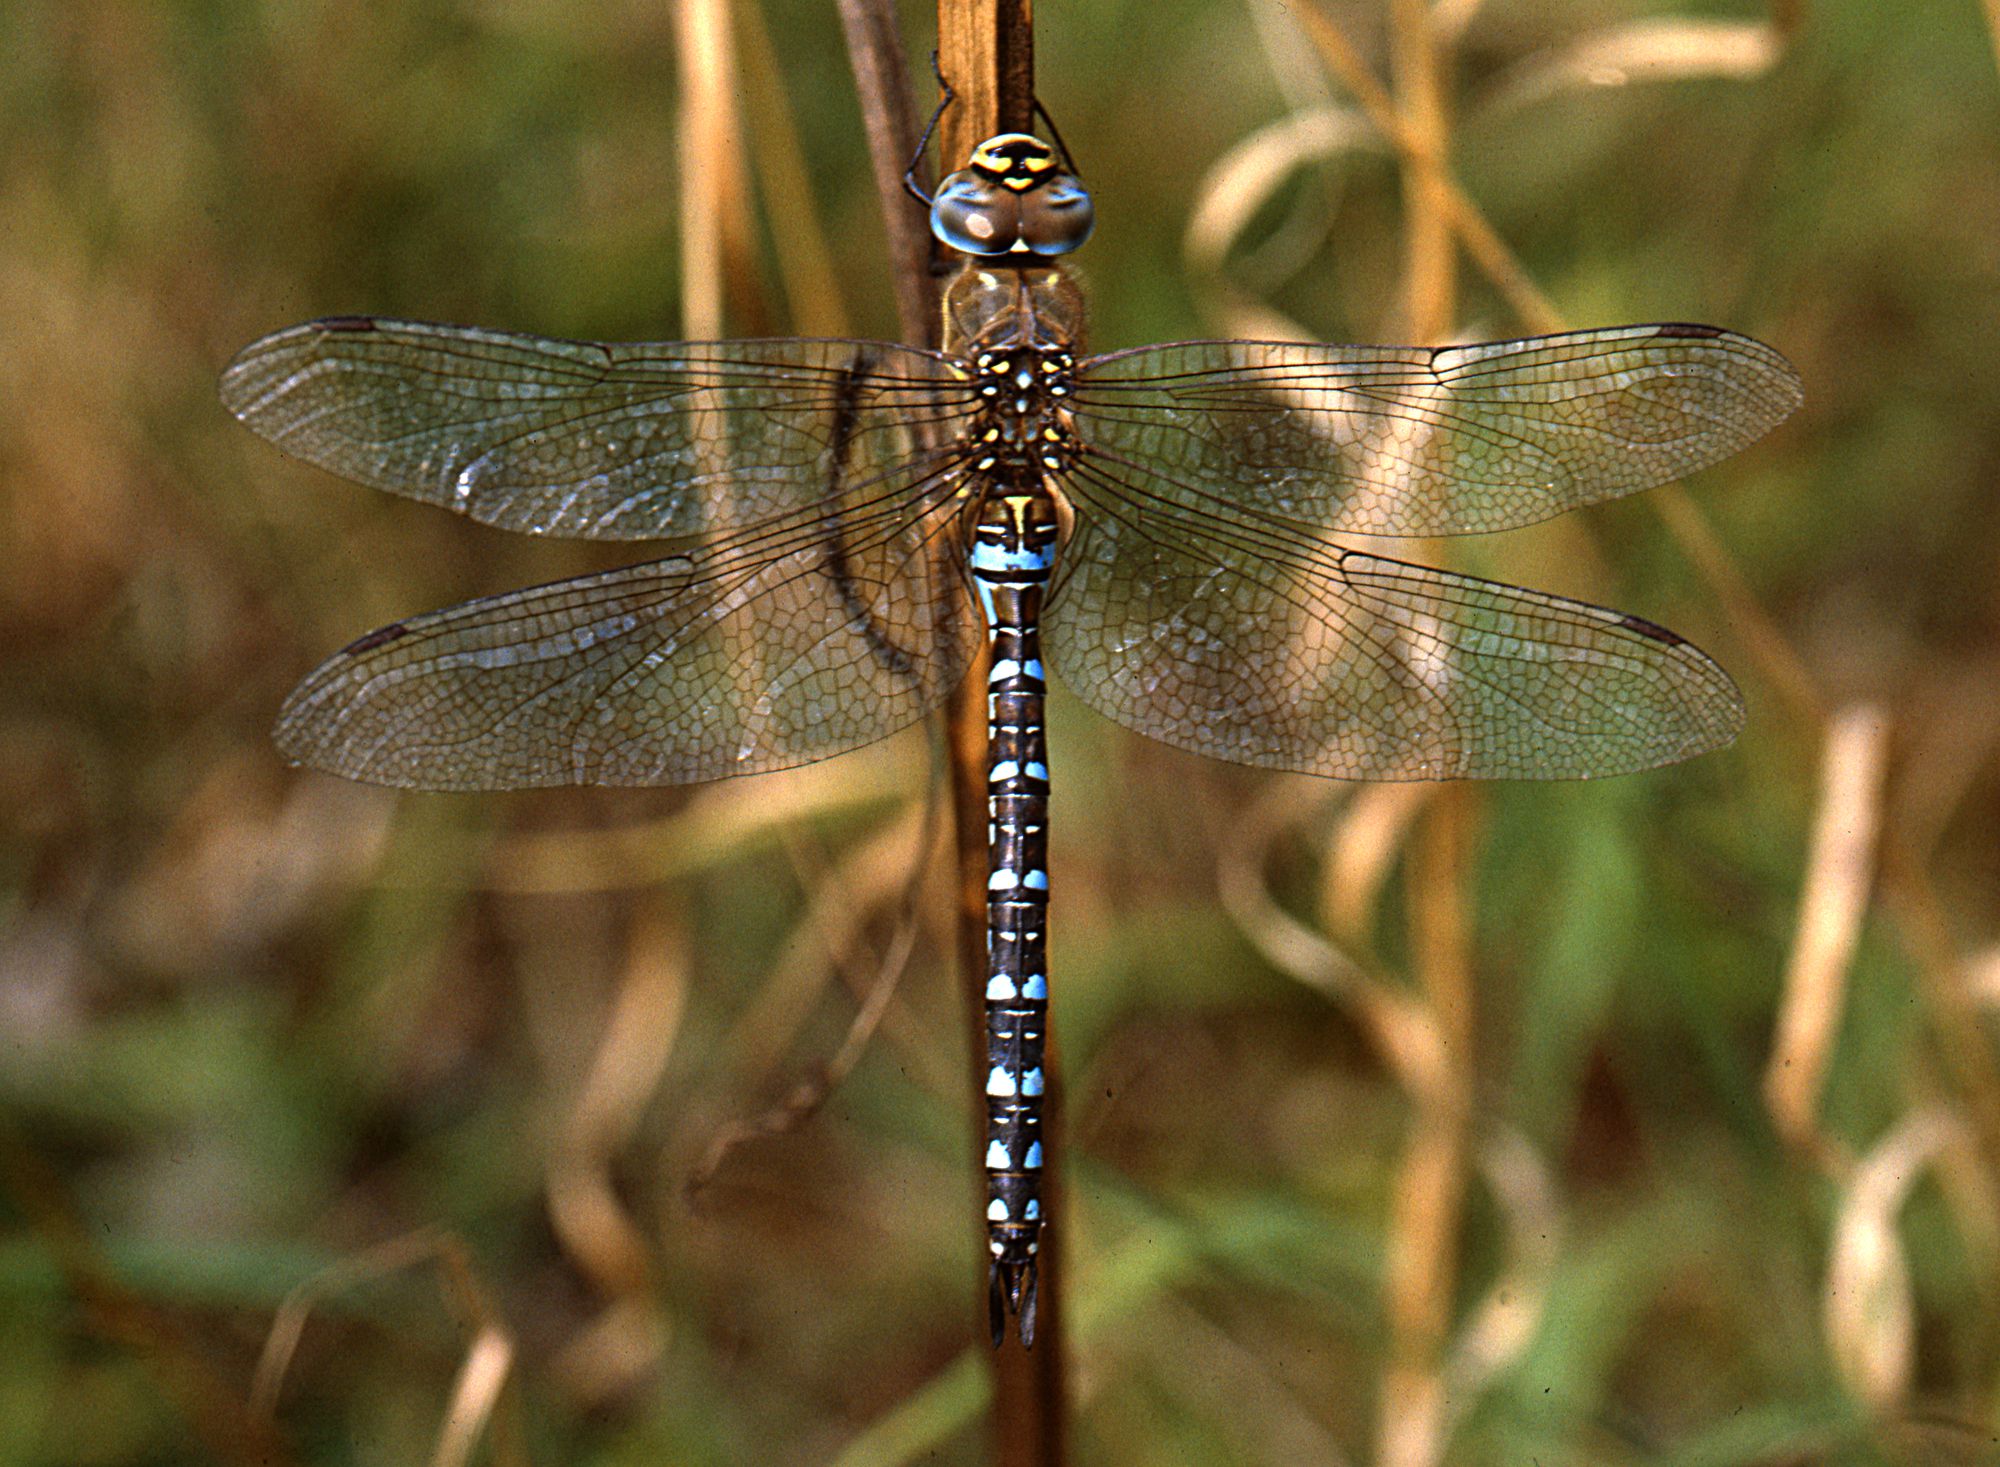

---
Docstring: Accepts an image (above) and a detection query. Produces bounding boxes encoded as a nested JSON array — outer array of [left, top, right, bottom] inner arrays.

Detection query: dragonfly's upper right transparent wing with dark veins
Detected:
[[1074, 326, 1800, 536]]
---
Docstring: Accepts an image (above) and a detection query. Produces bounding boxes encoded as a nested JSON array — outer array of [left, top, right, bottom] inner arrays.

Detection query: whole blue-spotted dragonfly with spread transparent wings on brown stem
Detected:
[[222, 132, 1800, 1345]]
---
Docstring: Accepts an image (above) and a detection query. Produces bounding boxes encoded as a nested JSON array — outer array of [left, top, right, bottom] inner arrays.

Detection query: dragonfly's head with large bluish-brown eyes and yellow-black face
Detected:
[[930, 132, 1096, 258]]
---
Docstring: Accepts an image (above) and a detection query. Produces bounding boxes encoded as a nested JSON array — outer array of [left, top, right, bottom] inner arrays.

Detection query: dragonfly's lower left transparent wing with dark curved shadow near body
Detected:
[[276, 468, 980, 789]]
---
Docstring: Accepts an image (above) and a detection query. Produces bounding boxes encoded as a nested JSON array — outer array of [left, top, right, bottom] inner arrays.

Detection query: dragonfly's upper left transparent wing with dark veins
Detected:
[[222, 316, 972, 540]]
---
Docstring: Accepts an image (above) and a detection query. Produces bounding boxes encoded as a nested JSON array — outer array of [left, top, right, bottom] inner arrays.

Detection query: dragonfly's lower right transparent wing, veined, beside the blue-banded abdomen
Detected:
[[1044, 466, 1742, 779]]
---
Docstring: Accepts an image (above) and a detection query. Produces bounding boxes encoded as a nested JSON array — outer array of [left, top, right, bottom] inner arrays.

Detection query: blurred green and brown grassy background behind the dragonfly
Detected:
[[0, 0, 2000, 1467]]
